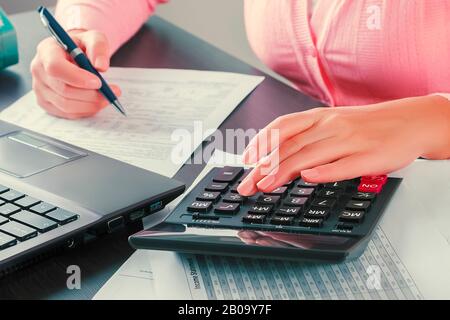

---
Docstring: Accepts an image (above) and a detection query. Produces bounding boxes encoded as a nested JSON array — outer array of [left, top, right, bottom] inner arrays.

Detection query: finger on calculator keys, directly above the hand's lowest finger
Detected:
[[256, 138, 359, 192]]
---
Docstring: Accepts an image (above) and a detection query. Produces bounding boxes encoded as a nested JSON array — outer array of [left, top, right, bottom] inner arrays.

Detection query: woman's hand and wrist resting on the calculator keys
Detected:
[[238, 96, 450, 196]]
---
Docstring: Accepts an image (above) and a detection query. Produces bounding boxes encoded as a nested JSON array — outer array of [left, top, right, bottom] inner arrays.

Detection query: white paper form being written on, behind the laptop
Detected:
[[0, 68, 264, 177]]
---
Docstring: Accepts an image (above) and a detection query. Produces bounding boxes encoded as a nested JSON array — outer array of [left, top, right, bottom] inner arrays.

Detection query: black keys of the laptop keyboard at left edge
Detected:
[[0, 185, 78, 250]]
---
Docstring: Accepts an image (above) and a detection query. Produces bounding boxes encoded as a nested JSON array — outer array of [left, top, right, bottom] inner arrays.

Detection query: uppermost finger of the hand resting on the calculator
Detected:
[[243, 112, 317, 164]]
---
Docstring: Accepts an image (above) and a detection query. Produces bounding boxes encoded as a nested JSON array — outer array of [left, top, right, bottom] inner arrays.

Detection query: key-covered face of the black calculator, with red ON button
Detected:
[[166, 167, 401, 236]]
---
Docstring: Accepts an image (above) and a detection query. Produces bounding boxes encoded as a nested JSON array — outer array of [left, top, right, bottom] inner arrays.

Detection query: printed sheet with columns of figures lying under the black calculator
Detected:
[[95, 152, 450, 299]]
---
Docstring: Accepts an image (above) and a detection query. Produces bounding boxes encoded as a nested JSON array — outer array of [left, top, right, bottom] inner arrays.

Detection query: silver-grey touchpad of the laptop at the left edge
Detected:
[[0, 132, 86, 178]]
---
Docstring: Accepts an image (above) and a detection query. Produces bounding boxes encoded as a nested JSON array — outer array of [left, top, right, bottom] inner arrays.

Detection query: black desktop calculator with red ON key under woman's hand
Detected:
[[129, 167, 401, 262]]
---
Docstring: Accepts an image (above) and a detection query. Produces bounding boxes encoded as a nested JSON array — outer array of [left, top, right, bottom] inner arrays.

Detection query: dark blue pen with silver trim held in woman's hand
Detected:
[[38, 7, 126, 116]]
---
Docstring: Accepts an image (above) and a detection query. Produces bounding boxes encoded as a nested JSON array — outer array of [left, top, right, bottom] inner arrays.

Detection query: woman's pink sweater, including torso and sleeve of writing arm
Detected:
[[57, 0, 450, 106]]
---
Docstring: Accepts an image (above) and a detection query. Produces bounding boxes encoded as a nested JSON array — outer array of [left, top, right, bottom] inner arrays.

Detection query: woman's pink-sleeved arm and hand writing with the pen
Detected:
[[30, 0, 166, 119]]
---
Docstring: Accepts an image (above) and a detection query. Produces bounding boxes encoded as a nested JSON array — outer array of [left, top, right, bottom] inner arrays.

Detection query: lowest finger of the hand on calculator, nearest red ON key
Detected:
[[302, 153, 400, 183]]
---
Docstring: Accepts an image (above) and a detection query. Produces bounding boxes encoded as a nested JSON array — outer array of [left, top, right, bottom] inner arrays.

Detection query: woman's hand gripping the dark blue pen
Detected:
[[31, 30, 120, 119]]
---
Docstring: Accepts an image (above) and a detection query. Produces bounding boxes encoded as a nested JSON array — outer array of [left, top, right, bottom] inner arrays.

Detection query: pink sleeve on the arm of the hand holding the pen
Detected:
[[56, 0, 168, 54]]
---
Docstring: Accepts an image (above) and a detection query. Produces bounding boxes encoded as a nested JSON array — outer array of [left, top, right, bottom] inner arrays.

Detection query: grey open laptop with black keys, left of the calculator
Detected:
[[0, 121, 185, 276]]
